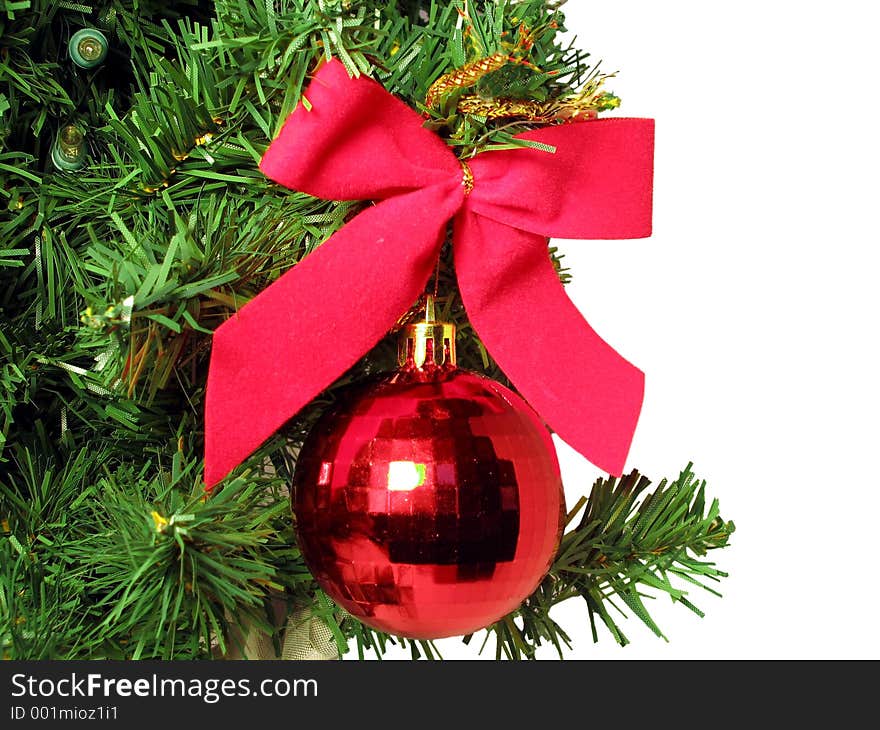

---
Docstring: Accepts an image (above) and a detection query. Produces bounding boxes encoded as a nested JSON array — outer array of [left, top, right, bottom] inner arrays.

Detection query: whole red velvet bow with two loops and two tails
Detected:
[[205, 61, 654, 487]]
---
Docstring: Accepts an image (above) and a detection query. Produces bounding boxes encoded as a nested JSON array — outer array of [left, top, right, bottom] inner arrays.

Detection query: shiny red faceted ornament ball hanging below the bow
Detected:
[[294, 366, 565, 639]]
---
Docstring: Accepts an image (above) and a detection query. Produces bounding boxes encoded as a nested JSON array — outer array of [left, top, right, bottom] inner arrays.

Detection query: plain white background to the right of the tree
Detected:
[[378, 0, 880, 659]]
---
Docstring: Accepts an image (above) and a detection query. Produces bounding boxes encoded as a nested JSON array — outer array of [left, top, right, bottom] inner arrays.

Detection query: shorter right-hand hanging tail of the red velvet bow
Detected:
[[454, 213, 644, 475]]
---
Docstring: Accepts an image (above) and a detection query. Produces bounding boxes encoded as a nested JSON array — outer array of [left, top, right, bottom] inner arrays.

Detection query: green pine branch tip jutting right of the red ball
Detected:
[[490, 464, 734, 658]]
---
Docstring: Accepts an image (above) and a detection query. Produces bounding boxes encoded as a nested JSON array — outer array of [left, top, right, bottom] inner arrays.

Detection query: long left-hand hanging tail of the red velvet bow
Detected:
[[205, 185, 461, 489]]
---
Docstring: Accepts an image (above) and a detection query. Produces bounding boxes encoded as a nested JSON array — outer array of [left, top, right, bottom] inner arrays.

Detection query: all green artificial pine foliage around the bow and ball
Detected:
[[0, 0, 733, 659]]
